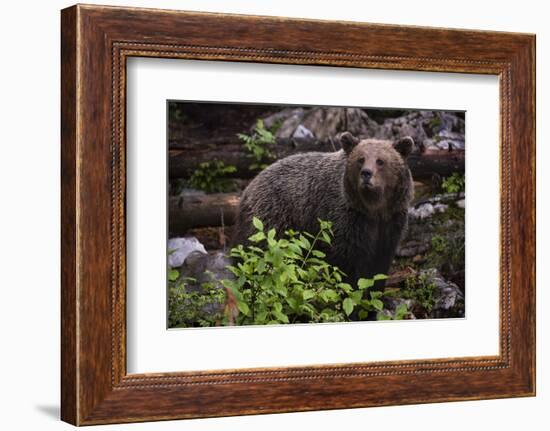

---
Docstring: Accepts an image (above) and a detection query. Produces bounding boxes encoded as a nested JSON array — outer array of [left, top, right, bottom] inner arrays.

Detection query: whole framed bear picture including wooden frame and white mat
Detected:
[[61, 5, 535, 425]]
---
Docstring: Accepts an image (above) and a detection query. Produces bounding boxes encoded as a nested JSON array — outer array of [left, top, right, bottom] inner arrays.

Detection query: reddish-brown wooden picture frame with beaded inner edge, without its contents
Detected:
[[61, 5, 535, 425]]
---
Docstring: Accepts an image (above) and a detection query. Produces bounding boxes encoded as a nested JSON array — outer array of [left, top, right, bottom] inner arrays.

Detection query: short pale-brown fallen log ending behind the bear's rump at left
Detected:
[[168, 193, 239, 235]]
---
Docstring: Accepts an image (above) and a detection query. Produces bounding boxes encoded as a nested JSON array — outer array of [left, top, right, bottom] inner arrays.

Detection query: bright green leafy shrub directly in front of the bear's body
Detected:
[[222, 218, 386, 325]]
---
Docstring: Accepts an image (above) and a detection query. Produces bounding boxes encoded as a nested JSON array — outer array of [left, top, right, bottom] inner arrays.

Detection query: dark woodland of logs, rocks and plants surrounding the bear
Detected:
[[168, 102, 465, 327]]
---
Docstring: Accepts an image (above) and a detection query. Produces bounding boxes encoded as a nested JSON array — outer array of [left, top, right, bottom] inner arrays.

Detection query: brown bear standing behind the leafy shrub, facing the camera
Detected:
[[233, 132, 414, 285]]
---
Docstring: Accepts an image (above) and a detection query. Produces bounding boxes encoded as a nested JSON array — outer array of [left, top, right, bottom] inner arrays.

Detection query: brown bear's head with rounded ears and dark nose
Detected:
[[338, 132, 414, 214]]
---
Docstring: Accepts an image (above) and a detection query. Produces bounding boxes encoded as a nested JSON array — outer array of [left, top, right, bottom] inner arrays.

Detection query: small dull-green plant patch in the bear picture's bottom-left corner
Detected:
[[168, 268, 227, 328]]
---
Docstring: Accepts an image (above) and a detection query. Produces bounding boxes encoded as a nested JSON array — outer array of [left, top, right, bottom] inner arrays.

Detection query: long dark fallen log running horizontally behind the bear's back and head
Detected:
[[168, 139, 465, 179]]
